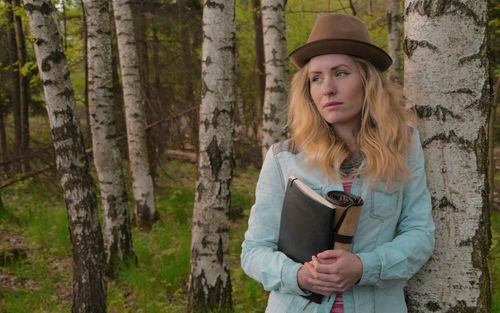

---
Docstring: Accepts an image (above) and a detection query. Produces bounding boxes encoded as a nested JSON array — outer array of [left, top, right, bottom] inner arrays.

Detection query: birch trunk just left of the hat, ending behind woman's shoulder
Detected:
[[262, 0, 288, 158]]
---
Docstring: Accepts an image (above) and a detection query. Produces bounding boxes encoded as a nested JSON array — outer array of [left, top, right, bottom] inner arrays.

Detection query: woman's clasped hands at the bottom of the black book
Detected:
[[308, 250, 363, 292]]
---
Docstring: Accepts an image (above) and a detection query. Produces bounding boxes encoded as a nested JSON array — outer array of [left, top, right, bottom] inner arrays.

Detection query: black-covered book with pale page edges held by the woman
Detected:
[[278, 177, 335, 303]]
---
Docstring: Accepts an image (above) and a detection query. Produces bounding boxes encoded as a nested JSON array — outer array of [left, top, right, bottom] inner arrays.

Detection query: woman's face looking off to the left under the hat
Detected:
[[309, 54, 364, 130]]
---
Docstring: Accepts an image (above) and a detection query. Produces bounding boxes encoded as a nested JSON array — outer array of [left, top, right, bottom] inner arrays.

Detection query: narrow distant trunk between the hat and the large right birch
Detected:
[[387, 0, 402, 85]]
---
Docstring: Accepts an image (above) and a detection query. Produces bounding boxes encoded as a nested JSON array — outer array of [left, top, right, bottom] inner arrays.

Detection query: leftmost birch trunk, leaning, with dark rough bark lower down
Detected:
[[24, 0, 106, 313]]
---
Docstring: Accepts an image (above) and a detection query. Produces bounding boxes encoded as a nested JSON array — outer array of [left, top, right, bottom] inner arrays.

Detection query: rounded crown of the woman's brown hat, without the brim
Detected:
[[307, 13, 371, 43]]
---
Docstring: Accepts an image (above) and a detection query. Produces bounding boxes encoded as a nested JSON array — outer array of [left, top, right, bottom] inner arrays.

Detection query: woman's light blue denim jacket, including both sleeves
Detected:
[[241, 130, 434, 313]]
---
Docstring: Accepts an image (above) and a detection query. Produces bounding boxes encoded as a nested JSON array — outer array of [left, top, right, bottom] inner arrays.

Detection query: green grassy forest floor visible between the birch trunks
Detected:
[[0, 152, 500, 313]]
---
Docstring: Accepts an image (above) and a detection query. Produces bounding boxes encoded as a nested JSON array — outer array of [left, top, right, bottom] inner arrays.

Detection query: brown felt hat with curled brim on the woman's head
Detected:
[[289, 13, 392, 72]]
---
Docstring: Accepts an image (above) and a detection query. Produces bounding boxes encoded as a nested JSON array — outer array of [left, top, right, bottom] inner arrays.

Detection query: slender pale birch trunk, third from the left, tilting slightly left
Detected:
[[113, 0, 158, 230]]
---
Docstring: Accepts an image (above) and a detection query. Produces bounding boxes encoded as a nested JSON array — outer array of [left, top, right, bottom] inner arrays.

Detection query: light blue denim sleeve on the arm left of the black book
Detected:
[[241, 149, 310, 295]]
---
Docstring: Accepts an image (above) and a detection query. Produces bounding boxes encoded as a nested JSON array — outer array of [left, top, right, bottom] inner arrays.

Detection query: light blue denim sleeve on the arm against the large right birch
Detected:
[[357, 130, 435, 287]]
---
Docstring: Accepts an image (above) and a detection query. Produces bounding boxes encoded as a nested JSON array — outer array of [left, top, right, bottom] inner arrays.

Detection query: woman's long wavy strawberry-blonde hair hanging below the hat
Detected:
[[288, 57, 416, 188]]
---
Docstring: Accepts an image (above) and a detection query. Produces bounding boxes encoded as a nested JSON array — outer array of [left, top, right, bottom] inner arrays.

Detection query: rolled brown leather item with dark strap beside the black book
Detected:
[[326, 190, 363, 252]]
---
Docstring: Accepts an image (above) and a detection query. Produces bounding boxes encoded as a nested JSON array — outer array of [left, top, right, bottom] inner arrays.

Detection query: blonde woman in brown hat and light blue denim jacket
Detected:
[[241, 14, 434, 313]]
